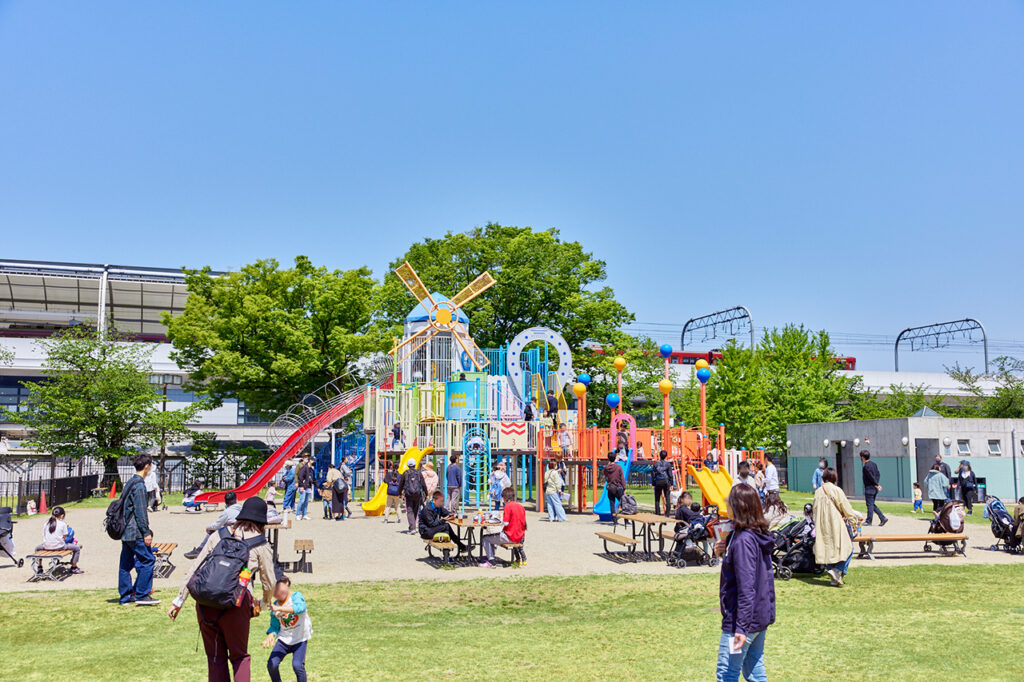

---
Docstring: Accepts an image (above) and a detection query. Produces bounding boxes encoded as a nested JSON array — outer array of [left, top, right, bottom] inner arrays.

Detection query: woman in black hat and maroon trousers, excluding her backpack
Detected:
[[168, 497, 278, 682]]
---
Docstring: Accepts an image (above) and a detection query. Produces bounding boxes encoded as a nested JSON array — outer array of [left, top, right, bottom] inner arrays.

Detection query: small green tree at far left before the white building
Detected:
[[0, 327, 204, 476]]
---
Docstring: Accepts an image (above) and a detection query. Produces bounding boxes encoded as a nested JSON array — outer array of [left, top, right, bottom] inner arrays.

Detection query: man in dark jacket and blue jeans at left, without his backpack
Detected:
[[118, 454, 160, 606]]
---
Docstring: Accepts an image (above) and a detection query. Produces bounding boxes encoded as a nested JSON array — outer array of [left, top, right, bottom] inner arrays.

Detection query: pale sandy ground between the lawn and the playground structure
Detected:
[[0, 504, 1011, 598]]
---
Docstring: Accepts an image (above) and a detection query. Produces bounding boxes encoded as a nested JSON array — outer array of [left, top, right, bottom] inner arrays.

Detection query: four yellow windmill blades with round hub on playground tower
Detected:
[[391, 261, 496, 372]]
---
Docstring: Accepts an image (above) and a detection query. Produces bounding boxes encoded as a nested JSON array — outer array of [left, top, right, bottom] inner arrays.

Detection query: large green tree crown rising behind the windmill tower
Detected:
[[379, 223, 633, 349]]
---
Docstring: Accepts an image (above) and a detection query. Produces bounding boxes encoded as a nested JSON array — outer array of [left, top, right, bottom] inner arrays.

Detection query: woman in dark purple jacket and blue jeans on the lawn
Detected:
[[715, 485, 775, 682]]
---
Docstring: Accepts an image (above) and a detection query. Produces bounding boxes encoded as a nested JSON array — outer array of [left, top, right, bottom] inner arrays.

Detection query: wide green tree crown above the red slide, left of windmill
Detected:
[[164, 256, 384, 417]]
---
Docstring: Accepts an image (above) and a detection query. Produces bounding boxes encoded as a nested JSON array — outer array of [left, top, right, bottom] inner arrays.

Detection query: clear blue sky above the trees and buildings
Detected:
[[0, 0, 1024, 370]]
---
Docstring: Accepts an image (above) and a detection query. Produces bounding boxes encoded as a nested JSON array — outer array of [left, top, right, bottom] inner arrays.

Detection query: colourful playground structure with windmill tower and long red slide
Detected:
[[200, 263, 760, 516]]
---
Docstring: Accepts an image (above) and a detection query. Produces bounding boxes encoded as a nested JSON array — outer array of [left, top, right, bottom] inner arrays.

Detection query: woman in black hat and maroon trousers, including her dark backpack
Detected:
[[168, 498, 278, 682]]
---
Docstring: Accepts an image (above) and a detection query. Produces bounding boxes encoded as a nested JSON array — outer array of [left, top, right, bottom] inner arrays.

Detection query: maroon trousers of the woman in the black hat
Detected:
[[196, 590, 253, 682]]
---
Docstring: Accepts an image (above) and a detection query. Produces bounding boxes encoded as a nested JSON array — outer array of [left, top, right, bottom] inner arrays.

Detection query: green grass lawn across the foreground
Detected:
[[0, 563, 1024, 681]]
